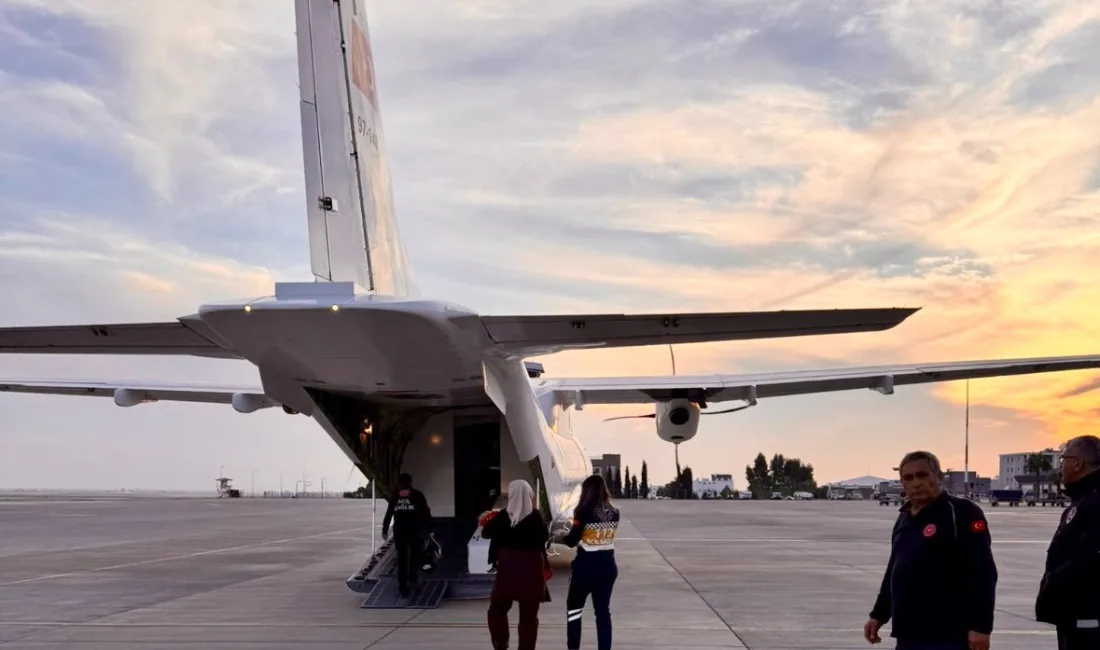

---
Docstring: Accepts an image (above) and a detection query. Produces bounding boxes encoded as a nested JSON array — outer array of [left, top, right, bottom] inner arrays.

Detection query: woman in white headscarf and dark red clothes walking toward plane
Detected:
[[482, 481, 550, 650]]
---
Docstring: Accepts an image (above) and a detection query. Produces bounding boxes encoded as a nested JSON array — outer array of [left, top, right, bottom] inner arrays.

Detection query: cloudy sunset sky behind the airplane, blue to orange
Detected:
[[0, 0, 1100, 489]]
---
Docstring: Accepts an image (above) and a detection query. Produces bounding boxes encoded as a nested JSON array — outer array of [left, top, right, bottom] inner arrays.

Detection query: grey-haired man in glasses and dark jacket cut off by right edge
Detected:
[[1035, 436, 1100, 650]]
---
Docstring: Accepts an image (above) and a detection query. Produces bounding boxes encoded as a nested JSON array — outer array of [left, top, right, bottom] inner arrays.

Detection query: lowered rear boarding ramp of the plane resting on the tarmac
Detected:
[[347, 517, 494, 609]]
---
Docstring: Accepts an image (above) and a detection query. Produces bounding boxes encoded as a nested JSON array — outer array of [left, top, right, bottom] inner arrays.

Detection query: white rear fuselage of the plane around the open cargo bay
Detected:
[[183, 283, 592, 532]]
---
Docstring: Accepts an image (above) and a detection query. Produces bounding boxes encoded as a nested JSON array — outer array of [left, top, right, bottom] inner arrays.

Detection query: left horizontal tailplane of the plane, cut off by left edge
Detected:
[[0, 321, 239, 359]]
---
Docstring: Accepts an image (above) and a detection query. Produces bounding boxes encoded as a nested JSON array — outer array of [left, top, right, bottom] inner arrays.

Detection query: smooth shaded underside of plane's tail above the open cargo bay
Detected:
[[200, 306, 483, 393]]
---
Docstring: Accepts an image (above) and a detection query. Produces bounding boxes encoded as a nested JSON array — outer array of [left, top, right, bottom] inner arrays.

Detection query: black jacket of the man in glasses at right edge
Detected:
[[1035, 471, 1100, 627]]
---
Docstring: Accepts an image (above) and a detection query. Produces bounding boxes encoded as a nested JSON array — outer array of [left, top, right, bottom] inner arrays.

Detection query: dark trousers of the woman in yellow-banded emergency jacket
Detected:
[[565, 551, 618, 650]]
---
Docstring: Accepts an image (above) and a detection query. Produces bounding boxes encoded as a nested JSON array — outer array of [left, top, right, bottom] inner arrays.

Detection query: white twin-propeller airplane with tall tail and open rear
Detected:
[[0, 0, 1100, 607]]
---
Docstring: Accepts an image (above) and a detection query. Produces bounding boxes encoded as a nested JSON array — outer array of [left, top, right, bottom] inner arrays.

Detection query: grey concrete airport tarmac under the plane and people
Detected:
[[0, 497, 1062, 650]]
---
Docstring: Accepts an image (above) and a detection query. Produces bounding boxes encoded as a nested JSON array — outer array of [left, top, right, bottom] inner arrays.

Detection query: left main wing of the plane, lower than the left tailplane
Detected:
[[0, 379, 281, 412]]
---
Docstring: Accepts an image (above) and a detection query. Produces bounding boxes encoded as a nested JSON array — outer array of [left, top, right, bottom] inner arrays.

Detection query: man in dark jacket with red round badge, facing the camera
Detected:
[[864, 451, 997, 650]]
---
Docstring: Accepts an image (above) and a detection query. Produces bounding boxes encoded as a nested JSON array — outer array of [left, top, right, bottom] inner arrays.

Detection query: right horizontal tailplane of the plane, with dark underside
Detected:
[[481, 308, 917, 356]]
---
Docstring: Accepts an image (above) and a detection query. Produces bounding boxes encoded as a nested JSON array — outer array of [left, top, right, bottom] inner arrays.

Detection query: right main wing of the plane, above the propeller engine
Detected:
[[543, 355, 1100, 404]]
